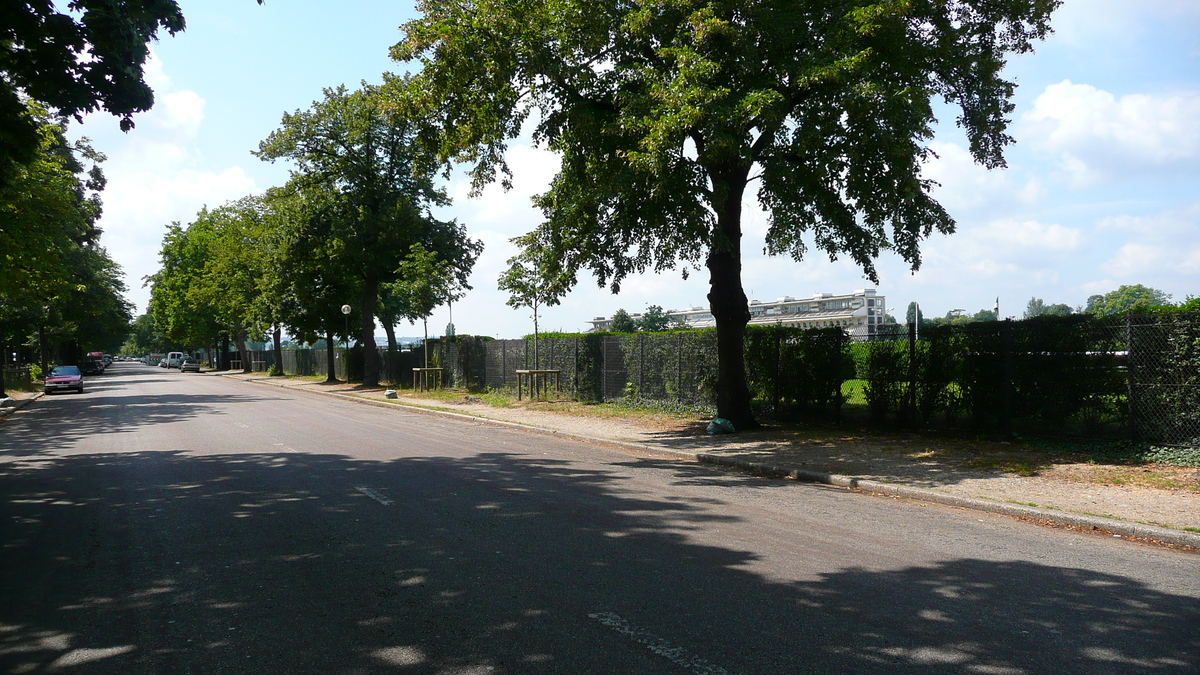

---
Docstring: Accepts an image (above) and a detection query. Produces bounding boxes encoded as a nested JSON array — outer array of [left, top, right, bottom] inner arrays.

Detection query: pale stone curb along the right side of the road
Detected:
[[223, 378, 1200, 549]]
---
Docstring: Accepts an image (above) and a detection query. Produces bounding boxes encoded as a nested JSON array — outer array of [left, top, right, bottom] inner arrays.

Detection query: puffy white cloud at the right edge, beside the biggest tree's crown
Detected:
[[1020, 79, 1200, 186]]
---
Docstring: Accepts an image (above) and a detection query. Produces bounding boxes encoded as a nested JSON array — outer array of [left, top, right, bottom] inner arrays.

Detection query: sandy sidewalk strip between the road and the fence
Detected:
[[224, 374, 1200, 549]]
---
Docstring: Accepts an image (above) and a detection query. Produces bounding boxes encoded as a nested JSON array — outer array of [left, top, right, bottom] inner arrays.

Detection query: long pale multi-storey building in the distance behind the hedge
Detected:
[[588, 288, 887, 338]]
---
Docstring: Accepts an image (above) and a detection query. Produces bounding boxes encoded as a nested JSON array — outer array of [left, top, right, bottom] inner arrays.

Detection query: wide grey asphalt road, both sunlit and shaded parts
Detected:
[[0, 364, 1200, 675]]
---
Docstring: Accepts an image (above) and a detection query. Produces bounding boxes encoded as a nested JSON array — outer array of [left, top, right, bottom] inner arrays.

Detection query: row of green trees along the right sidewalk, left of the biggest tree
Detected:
[[148, 84, 482, 386]]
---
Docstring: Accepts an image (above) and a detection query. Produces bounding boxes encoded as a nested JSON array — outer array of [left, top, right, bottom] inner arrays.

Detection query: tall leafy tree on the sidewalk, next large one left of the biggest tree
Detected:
[[257, 84, 477, 387]]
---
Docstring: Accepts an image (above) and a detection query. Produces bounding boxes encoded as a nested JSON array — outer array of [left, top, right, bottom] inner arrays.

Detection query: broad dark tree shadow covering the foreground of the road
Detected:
[[0, 444, 1200, 674]]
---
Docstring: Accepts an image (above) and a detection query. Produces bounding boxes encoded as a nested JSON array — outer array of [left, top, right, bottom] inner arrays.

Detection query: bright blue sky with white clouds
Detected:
[[71, 0, 1200, 338]]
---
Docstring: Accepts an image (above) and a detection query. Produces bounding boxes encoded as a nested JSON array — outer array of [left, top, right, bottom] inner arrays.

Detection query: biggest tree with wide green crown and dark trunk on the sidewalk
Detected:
[[392, 0, 1058, 429]]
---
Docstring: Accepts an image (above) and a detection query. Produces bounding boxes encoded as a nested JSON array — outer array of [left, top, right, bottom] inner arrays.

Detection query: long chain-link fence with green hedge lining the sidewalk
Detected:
[[256, 313, 1200, 446]]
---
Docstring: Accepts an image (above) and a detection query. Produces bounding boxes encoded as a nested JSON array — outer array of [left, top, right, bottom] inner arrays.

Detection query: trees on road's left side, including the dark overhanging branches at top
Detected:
[[0, 0, 262, 395]]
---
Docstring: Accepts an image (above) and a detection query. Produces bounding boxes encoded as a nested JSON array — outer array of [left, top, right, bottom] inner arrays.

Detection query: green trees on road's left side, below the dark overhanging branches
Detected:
[[0, 107, 132, 395]]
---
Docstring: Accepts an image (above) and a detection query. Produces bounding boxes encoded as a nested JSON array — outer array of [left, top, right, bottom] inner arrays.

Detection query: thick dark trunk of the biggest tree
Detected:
[[706, 167, 758, 431]]
